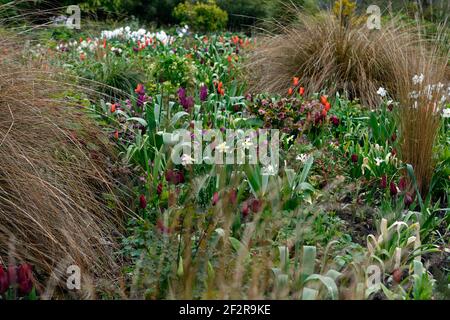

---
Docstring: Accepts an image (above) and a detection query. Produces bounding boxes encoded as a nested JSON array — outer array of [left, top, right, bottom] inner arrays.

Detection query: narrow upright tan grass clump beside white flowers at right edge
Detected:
[[394, 46, 450, 196]]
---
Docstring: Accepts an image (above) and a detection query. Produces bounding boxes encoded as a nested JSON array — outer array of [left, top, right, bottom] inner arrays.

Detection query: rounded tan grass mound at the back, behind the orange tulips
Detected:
[[247, 10, 426, 106]]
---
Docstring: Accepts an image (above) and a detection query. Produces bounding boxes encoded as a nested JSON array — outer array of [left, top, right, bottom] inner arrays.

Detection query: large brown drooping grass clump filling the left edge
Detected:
[[0, 34, 125, 294]]
